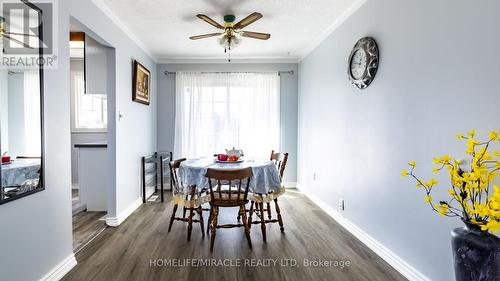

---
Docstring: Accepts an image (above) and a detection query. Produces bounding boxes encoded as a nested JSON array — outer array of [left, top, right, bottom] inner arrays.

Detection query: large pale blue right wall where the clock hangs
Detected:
[[298, 0, 500, 281]]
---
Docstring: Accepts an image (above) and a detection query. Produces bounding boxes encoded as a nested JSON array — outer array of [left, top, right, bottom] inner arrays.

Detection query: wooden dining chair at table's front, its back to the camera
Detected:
[[206, 168, 252, 251]]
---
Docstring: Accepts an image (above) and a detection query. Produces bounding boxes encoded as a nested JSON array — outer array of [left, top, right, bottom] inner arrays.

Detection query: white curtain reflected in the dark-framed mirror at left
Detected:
[[24, 71, 42, 156]]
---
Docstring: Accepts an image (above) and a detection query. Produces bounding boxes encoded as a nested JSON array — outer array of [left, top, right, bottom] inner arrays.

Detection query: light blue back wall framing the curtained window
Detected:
[[158, 63, 298, 182]]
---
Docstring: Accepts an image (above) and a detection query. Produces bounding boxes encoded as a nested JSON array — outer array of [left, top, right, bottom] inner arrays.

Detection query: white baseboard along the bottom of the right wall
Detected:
[[297, 184, 431, 281]]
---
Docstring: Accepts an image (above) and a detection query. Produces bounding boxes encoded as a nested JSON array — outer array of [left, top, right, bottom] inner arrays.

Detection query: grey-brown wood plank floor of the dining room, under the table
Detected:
[[63, 190, 406, 281]]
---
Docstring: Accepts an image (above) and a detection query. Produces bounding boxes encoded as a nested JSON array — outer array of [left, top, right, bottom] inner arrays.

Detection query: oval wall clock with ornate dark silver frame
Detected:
[[347, 37, 378, 89]]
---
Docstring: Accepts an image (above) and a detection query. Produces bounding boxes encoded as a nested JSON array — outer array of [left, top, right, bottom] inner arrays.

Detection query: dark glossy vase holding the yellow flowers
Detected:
[[451, 223, 500, 281]]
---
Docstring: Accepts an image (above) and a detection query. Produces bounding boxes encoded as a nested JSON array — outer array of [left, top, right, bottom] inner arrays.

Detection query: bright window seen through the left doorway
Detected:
[[71, 72, 108, 131]]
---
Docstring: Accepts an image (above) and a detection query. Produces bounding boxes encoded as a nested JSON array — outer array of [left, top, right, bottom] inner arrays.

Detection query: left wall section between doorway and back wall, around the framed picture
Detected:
[[66, 0, 157, 220]]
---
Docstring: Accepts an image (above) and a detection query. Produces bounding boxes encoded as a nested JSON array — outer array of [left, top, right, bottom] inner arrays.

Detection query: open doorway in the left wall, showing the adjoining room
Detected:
[[69, 18, 114, 254]]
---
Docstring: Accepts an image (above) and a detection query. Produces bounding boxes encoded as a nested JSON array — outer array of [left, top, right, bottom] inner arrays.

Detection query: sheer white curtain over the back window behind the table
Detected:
[[174, 72, 280, 157]]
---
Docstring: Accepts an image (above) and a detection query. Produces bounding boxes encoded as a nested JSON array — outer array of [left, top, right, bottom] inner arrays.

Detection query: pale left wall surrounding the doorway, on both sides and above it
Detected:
[[0, 0, 156, 281]]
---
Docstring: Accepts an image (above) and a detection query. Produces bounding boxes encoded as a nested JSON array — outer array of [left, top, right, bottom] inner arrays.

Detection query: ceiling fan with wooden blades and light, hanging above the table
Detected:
[[189, 12, 271, 61]]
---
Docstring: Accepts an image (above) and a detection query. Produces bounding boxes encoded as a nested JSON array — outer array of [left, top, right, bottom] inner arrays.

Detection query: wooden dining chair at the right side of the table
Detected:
[[248, 150, 288, 242]]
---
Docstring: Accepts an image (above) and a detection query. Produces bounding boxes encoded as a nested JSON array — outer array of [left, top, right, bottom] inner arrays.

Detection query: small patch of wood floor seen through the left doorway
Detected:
[[73, 212, 107, 252]]
